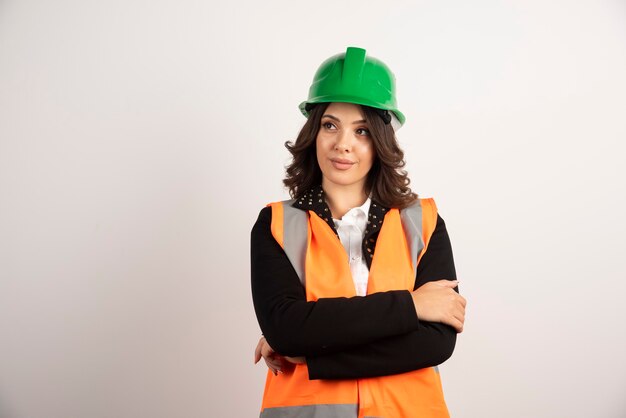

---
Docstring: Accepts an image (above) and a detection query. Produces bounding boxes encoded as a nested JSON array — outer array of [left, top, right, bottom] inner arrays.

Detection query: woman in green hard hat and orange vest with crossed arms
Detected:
[[251, 48, 466, 418]]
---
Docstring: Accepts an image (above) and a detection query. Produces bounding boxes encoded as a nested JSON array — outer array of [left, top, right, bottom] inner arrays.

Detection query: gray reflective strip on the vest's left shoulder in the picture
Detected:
[[281, 200, 309, 286]]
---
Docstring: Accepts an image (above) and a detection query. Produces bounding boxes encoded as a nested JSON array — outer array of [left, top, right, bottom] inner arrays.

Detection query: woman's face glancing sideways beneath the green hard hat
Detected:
[[316, 103, 375, 189]]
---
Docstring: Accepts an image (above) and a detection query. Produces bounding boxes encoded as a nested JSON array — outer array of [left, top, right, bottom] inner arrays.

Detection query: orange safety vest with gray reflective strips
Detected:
[[261, 199, 450, 418]]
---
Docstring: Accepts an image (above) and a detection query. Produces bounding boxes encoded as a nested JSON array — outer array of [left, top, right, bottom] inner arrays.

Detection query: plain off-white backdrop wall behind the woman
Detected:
[[0, 0, 626, 418]]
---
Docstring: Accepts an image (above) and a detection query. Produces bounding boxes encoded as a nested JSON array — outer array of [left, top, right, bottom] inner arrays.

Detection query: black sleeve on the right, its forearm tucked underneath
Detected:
[[307, 217, 458, 379]]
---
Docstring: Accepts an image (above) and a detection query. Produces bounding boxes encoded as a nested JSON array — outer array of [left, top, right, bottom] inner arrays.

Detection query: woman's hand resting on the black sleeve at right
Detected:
[[411, 279, 467, 332]]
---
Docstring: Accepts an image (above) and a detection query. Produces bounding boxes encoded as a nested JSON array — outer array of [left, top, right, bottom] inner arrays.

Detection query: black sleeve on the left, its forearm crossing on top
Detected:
[[251, 207, 419, 356]]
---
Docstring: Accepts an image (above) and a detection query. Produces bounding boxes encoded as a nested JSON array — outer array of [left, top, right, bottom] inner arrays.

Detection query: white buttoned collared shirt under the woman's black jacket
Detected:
[[333, 197, 371, 296]]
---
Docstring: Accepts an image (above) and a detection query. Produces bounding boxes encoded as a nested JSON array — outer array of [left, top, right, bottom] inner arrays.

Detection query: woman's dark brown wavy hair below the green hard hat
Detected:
[[283, 103, 417, 209]]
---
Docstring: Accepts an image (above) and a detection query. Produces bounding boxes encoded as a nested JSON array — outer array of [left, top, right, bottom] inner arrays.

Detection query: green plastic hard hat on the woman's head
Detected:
[[300, 47, 406, 126]]
